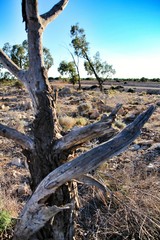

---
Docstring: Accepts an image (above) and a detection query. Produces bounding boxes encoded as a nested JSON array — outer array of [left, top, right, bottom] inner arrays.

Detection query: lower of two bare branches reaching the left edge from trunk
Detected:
[[0, 124, 34, 150]]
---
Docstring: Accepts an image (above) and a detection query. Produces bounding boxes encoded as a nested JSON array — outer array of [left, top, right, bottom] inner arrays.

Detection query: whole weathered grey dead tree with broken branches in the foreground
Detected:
[[0, 0, 154, 240]]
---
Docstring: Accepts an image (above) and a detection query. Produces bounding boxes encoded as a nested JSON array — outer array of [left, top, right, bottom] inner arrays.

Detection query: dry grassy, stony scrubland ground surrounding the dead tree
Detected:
[[0, 83, 160, 240]]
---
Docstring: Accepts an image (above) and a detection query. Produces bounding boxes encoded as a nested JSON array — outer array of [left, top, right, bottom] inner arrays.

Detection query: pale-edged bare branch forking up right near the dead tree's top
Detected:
[[41, 0, 69, 27]]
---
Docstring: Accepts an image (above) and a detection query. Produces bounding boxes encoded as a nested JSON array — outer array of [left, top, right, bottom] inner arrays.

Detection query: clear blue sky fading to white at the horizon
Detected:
[[0, 0, 160, 78]]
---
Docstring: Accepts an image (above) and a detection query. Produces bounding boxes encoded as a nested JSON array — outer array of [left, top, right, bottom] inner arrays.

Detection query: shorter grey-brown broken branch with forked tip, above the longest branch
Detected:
[[53, 104, 122, 151]]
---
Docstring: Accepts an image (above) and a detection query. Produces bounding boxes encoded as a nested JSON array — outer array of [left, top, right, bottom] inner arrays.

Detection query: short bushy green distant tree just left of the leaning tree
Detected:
[[58, 61, 78, 85]]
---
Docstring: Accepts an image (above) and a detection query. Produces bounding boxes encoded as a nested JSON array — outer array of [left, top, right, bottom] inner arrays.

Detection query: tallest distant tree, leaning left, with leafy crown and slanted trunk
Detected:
[[70, 23, 115, 91]]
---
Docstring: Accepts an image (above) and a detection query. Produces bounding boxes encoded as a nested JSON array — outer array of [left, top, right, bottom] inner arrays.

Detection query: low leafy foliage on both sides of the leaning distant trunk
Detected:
[[84, 52, 116, 85]]
